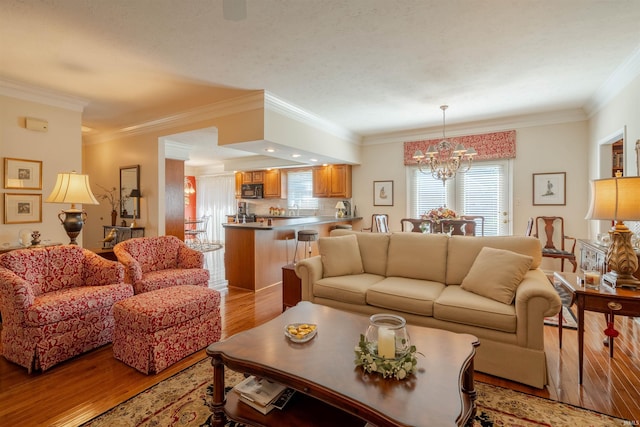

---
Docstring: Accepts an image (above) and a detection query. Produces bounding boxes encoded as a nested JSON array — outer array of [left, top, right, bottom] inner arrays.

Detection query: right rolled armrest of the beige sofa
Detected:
[[515, 268, 562, 350]]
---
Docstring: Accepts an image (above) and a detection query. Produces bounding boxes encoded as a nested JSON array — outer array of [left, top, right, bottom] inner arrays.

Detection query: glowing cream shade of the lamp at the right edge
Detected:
[[586, 176, 640, 221]]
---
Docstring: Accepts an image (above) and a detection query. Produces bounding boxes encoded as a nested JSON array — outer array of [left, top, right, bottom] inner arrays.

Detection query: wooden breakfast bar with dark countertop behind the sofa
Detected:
[[223, 216, 362, 291]]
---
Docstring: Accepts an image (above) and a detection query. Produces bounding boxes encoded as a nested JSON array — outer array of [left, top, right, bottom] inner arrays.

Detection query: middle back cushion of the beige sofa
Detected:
[[386, 232, 449, 283]]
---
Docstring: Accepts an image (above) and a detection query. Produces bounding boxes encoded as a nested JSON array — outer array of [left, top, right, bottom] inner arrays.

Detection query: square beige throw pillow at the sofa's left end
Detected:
[[318, 235, 364, 277]]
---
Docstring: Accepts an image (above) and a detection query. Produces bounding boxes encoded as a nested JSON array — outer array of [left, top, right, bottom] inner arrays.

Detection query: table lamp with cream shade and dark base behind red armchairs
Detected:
[[45, 172, 99, 245]]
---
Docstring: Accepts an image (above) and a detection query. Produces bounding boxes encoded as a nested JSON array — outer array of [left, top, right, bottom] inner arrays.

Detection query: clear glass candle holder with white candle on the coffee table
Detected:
[[365, 314, 411, 359]]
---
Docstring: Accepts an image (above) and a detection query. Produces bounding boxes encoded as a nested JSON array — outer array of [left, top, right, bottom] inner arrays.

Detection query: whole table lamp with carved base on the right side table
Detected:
[[586, 176, 640, 289]]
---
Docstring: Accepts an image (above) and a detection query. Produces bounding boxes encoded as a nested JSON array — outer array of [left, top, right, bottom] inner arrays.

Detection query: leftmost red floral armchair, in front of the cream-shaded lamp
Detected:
[[0, 245, 133, 372]]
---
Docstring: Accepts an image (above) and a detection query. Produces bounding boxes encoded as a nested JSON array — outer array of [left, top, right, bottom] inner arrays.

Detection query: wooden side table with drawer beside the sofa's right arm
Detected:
[[553, 272, 640, 384]]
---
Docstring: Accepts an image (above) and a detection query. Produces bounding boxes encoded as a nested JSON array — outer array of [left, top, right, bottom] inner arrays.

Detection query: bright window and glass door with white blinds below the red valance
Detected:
[[407, 160, 510, 236]]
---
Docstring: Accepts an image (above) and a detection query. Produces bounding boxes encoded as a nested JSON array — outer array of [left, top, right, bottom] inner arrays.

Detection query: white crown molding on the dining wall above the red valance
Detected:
[[363, 108, 587, 145]]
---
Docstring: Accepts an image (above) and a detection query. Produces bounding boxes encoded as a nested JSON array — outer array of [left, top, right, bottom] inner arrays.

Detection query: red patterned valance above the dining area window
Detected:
[[404, 130, 516, 166]]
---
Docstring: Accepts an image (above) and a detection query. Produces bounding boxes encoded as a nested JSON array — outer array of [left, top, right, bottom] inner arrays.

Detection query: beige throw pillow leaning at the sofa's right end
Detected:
[[460, 247, 533, 304]]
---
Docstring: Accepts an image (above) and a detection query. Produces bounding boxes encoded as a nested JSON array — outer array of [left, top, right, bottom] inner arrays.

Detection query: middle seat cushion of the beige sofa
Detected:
[[367, 277, 445, 316]]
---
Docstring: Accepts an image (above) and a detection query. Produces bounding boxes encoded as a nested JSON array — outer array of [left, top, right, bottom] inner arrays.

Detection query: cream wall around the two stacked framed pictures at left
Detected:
[[0, 93, 84, 246]]
